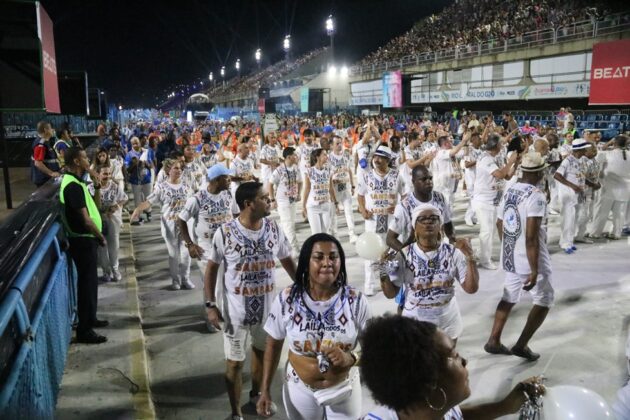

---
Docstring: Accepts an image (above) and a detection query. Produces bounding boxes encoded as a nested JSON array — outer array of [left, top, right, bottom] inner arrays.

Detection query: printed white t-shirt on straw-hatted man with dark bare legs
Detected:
[[497, 182, 551, 275]]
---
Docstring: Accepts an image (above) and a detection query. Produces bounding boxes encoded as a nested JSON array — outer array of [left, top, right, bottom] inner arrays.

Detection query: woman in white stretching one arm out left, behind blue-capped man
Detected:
[[131, 159, 195, 290]]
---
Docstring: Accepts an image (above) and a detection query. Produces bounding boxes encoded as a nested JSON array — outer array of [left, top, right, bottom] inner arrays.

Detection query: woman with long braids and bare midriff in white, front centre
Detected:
[[256, 233, 370, 420]]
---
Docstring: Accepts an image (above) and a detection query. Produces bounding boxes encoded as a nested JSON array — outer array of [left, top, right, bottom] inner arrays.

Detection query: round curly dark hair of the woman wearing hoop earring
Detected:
[[360, 315, 446, 411]]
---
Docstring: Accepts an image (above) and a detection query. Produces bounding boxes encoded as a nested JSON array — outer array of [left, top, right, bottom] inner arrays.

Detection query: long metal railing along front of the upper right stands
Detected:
[[350, 12, 630, 76]]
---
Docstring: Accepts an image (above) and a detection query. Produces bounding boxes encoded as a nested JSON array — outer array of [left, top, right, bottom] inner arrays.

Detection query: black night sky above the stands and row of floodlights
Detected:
[[41, 0, 451, 107]]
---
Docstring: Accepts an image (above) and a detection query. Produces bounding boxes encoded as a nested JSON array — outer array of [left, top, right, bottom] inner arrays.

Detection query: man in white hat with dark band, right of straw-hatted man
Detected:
[[554, 139, 597, 254]]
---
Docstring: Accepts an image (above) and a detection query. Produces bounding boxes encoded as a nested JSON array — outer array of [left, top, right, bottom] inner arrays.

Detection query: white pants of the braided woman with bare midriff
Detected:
[[282, 363, 362, 420]]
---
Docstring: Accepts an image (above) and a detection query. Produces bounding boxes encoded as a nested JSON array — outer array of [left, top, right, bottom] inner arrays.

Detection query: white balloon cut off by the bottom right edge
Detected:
[[543, 385, 614, 420]]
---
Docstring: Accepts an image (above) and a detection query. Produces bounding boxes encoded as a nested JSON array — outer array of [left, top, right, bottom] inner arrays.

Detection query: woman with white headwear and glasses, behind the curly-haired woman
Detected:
[[381, 203, 479, 341]]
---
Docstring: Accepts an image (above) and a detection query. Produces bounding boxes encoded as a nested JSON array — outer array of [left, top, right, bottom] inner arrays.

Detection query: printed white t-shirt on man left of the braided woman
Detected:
[[210, 218, 291, 326]]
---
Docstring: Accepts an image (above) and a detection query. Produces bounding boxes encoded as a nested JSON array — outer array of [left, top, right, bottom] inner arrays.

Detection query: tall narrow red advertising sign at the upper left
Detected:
[[37, 2, 61, 114]]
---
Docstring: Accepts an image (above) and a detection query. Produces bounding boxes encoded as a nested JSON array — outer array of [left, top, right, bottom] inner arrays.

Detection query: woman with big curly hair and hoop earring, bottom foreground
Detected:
[[360, 316, 545, 420]]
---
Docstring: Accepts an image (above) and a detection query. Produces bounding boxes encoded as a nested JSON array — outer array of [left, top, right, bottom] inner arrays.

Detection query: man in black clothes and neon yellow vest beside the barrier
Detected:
[[59, 147, 109, 344]]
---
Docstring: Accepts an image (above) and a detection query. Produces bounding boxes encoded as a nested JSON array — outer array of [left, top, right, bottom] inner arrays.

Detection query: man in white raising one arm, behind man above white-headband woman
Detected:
[[431, 135, 470, 210]]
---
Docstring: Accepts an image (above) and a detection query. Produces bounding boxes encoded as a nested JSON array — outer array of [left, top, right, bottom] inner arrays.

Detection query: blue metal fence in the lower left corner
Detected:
[[0, 223, 77, 419]]
